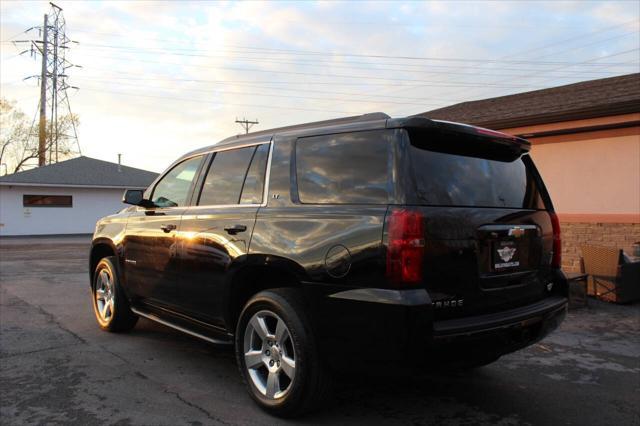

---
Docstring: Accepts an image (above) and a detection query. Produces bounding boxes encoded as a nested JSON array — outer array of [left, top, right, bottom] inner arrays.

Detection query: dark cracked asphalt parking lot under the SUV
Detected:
[[0, 237, 640, 426]]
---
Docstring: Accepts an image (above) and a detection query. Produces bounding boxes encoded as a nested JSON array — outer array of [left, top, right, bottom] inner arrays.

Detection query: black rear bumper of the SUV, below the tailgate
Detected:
[[314, 282, 568, 366]]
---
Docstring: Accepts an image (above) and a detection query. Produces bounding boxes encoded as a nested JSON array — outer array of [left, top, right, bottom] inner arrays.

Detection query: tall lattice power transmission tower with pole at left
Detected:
[[14, 3, 81, 166]]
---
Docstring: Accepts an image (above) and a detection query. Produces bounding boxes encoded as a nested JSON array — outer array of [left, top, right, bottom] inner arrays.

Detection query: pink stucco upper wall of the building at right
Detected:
[[498, 112, 640, 223]]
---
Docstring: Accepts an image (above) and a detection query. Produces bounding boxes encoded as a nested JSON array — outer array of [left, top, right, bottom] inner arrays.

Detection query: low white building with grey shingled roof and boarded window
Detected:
[[0, 157, 157, 236]]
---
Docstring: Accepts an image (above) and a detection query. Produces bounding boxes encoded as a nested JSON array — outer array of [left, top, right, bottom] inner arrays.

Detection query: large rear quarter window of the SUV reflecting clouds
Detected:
[[296, 130, 390, 204]]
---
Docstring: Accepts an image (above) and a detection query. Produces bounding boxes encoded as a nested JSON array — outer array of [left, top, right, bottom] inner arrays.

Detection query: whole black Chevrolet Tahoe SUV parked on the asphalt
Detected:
[[90, 113, 567, 416]]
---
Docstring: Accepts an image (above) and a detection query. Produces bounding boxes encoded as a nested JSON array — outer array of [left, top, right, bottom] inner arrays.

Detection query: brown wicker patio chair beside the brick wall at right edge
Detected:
[[582, 245, 640, 303]]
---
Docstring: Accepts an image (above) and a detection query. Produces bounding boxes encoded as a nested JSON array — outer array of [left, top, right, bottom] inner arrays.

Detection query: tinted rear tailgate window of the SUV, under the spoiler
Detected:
[[411, 145, 544, 209]]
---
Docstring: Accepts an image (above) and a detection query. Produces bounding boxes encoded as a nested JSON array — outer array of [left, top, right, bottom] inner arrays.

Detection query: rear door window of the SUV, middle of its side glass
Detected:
[[198, 146, 256, 206]]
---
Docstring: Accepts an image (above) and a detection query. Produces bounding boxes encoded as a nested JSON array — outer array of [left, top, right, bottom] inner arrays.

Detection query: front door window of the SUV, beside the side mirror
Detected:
[[151, 156, 203, 207]]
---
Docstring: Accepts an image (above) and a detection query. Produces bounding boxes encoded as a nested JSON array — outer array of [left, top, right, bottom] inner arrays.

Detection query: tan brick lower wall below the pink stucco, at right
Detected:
[[560, 222, 640, 272]]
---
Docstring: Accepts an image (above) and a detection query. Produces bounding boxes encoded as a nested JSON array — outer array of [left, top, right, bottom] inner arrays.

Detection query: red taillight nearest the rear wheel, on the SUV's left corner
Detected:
[[387, 210, 425, 286]]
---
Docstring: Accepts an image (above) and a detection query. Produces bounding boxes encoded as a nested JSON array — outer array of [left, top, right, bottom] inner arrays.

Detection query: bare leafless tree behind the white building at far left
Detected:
[[0, 99, 79, 173]]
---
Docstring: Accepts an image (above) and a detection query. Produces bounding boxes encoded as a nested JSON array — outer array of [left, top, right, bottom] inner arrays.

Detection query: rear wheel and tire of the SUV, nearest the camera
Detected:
[[235, 288, 330, 417]]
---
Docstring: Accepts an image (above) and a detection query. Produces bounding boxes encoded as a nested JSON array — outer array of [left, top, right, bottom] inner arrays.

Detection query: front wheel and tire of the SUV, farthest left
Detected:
[[91, 256, 138, 332]]
